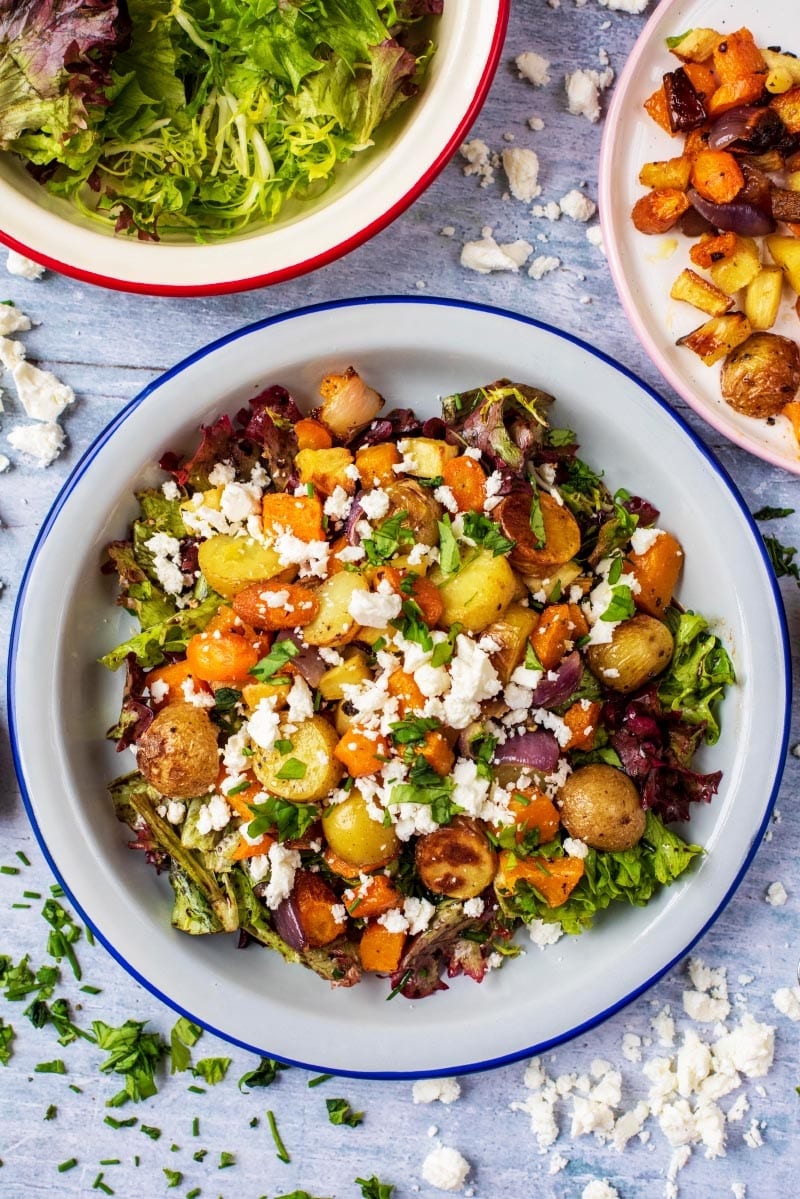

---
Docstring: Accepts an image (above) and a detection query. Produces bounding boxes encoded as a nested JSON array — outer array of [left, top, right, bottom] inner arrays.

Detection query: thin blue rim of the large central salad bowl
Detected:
[[6, 295, 792, 1081]]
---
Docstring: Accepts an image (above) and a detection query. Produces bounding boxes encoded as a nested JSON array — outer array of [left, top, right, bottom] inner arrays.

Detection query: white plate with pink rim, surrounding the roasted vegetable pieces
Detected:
[[599, 0, 800, 474]]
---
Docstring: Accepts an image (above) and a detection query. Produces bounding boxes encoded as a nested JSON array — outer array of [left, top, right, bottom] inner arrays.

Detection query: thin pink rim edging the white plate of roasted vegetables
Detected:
[[597, 0, 800, 475]]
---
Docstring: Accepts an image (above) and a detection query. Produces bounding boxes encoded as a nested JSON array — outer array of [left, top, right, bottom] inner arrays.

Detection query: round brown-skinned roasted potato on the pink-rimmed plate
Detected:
[[720, 332, 800, 417]]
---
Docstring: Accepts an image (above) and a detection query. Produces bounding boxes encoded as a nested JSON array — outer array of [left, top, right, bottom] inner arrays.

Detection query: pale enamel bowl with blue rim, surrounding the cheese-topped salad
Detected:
[[10, 299, 789, 1077]]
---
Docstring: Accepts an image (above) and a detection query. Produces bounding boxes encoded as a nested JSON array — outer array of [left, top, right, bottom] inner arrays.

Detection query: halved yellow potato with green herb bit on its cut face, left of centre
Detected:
[[252, 716, 342, 803]]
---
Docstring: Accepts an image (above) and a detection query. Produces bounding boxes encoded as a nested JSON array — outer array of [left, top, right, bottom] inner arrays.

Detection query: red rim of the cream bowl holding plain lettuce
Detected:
[[0, 0, 511, 296]]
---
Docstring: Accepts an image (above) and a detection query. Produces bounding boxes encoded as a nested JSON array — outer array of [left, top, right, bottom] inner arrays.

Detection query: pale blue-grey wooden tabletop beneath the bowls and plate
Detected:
[[0, 0, 800, 1199]]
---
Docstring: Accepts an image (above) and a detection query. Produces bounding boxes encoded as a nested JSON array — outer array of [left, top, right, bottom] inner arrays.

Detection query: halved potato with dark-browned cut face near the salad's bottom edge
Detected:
[[415, 817, 498, 899]]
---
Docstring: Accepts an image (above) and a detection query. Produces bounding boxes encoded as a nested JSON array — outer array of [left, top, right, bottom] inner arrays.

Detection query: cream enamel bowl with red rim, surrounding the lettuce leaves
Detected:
[[0, 0, 509, 295]]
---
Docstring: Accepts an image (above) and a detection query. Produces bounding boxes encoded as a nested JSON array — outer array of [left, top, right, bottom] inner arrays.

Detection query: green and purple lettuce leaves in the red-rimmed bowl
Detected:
[[0, 0, 443, 241]]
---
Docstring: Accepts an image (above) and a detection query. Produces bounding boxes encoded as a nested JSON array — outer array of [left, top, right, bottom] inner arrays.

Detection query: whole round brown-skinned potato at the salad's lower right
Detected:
[[559, 763, 645, 850]]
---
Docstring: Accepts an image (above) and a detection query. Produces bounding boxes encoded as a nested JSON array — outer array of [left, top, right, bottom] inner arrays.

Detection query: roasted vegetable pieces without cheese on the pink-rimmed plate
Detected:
[[632, 29, 800, 441]]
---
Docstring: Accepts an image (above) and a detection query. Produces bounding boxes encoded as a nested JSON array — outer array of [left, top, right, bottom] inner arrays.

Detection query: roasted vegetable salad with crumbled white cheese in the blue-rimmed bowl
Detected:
[[103, 368, 734, 998]]
